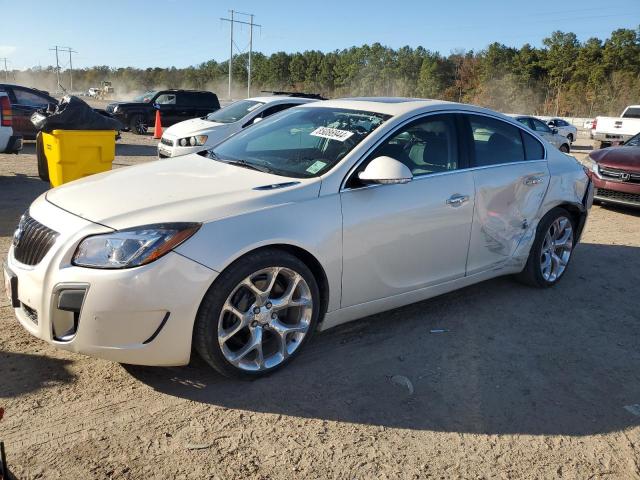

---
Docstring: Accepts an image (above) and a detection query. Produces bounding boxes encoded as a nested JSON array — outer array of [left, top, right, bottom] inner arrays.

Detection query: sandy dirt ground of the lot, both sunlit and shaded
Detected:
[[0, 134, 640, 479]]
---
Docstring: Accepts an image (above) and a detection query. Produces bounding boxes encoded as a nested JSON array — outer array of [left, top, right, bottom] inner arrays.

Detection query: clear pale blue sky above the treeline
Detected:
[[0, 0, 640, 70]]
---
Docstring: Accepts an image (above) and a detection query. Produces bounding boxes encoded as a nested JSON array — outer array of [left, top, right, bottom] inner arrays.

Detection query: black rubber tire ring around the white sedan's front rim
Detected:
[[194, 249, 320, 379]]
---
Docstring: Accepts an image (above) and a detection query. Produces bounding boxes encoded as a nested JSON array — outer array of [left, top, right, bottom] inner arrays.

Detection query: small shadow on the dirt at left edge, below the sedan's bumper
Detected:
[[0, 350, 75, 398]]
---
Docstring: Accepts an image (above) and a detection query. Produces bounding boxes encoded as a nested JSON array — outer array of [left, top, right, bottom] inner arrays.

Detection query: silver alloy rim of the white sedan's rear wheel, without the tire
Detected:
[[540, 216, 573, 282]]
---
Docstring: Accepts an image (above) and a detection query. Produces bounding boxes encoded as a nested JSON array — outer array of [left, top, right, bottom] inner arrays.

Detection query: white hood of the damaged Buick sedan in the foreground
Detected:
[[46, 154, 320, 229]]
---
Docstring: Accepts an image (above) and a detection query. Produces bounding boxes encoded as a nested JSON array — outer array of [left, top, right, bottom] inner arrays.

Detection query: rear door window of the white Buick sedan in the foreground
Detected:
[[468, 115, 525, 167]]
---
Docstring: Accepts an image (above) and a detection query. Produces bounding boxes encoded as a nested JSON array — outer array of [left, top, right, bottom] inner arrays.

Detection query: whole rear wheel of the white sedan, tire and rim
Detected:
[[516, 207, 576, 288]]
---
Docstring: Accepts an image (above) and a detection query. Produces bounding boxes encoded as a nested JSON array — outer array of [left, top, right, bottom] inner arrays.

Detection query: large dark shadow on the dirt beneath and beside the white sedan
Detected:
[[125, 244, 640, 435]]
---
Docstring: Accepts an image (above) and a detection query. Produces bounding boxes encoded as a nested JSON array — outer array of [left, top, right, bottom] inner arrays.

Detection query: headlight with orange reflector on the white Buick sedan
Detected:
[[72, 223, 200, 269]]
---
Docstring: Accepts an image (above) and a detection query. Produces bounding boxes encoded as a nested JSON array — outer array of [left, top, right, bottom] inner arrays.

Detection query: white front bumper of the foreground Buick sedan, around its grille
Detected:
[[7, 197, 216, 365]]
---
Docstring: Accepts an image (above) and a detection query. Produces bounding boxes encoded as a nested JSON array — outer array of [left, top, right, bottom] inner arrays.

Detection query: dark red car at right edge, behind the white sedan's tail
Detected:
[[586, 133, 640, 207]]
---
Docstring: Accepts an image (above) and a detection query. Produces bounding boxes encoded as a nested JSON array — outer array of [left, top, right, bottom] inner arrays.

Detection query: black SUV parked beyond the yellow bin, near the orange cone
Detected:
[[106, 90, 220, 135]]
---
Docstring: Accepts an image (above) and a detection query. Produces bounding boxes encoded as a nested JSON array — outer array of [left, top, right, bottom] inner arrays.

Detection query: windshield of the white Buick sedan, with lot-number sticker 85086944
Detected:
[[208, 107, 390, 178]]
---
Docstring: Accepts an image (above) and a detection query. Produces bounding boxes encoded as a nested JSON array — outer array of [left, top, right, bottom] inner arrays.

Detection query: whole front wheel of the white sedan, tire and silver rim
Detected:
[[194, 249, 321, 379]]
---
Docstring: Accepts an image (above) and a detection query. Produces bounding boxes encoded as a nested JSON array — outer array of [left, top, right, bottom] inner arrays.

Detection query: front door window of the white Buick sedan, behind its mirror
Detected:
[[361, 115, 460, 176]]
